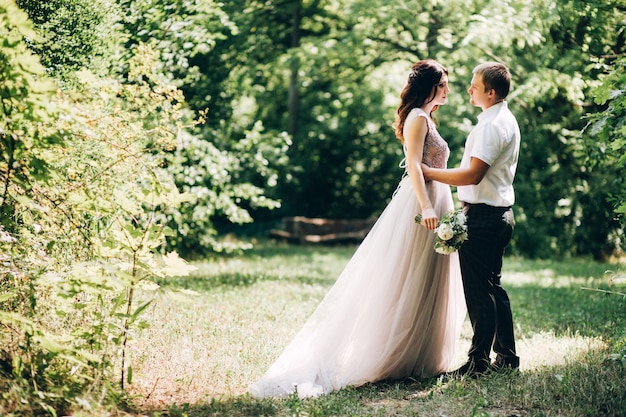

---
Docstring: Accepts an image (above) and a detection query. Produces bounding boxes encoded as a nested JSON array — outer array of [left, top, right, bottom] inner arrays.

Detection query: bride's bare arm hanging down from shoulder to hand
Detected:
[[404, 117, 438, 230]]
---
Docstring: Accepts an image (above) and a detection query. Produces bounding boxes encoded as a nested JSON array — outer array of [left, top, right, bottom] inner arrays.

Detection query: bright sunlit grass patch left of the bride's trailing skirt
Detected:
[[126, 282, 327, 405]]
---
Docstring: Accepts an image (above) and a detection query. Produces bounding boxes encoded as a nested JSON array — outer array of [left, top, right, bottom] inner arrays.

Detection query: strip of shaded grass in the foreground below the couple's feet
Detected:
[[130, 352, 626, 417]]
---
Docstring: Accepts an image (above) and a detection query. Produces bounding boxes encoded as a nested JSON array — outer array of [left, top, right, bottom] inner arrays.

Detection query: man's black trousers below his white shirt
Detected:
[[459, 204, 519, 363]]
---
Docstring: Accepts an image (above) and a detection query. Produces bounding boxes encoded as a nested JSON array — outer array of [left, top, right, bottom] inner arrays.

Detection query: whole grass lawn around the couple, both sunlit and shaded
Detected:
[[123, 242, 626, 417]]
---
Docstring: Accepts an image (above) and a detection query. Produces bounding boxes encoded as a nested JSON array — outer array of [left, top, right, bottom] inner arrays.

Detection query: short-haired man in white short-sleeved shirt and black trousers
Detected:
[[422, 62, 520, 378]]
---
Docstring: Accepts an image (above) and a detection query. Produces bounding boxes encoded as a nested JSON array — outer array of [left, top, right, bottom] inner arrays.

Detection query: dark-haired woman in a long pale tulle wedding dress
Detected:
[[248, 59, 465, 398]]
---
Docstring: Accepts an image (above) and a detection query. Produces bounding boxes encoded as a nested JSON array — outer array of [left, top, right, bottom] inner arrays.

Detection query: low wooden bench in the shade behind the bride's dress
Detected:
[[270, 216, 376, 243]]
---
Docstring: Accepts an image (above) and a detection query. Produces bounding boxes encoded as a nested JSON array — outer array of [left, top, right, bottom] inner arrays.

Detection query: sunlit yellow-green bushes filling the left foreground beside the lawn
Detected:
[[0, 0, 196, 415]]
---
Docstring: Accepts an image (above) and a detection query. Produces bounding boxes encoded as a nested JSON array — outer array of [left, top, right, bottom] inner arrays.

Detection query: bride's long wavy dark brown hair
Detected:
[[393, 59, 448, 143]]
